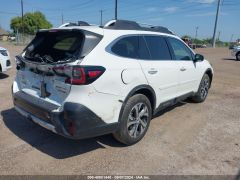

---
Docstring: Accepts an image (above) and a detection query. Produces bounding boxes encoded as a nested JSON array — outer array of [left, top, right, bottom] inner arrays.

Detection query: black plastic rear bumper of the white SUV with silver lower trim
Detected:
[[13, 91, 119, 139]]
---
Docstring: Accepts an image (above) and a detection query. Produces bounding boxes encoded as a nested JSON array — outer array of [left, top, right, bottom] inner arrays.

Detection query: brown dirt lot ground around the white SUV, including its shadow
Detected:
[[0, 41, 240, 175]]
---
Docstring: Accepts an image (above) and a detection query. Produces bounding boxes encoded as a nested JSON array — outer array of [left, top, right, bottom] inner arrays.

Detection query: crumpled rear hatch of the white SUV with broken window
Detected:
[[16, 29, 102, 106]]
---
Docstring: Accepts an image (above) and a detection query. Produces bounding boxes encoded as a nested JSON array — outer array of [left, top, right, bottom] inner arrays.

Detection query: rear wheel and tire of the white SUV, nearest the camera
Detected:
[[113, 94, 152, 145]]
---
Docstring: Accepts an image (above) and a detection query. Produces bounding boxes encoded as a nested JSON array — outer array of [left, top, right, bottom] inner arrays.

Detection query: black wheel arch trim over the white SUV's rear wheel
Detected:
[[118, 85, 156, 122]]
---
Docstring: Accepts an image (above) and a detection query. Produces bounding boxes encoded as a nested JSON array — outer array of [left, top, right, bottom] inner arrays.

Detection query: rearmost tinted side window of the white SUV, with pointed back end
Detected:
[[112, 36, 138, 58]]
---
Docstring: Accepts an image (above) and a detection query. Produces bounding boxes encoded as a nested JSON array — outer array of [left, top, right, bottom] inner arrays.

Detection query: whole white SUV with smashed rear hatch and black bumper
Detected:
[[12, 20, 213, 145]]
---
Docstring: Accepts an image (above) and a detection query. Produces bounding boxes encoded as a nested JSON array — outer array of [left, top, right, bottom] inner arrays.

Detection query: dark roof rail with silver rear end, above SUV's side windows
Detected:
[[103, 20, 174, 34]]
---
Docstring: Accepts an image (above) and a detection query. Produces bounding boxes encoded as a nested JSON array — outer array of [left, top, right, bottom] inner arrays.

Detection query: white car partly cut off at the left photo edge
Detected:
[[0, 47, 11, 73]]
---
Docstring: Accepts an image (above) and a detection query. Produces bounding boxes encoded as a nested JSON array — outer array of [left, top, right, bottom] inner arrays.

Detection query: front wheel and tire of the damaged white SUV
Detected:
[[192, 74, 211, 103]]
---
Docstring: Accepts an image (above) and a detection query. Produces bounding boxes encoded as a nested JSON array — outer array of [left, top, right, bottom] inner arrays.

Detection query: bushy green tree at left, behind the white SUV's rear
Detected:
[[10, 11, 52, 34]]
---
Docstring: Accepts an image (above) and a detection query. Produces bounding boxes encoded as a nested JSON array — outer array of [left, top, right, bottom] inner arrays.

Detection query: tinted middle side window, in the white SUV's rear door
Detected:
[[144, 36, 172, 61]]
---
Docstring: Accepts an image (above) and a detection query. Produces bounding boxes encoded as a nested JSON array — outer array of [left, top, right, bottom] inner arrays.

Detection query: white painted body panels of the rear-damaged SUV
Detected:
[[13, 27, 212, 126]]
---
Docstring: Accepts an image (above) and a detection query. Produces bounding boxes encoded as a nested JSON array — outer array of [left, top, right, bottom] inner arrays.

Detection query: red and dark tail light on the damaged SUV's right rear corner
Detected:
[[53, 66, 105, 85]]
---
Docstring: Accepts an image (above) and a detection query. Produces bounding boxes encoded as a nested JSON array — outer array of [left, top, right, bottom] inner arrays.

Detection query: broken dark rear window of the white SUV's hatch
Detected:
[[25, 30, 101, 63]]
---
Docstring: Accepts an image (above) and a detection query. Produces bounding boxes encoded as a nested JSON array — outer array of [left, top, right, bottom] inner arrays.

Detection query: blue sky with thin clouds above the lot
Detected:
[[0, 0, 240, 41]]
